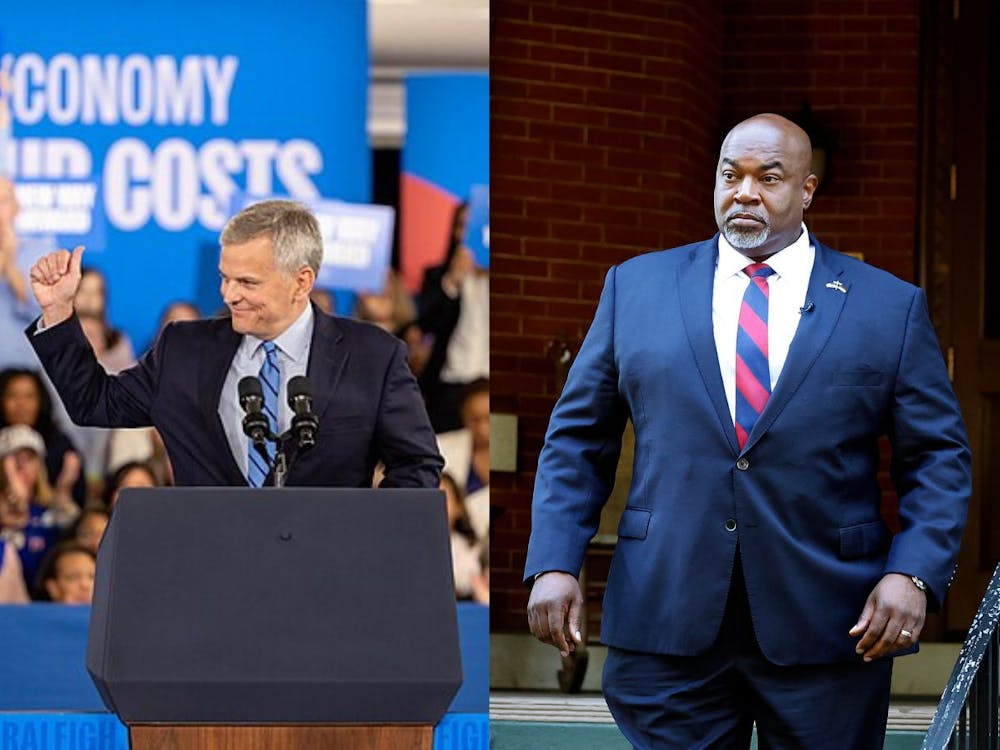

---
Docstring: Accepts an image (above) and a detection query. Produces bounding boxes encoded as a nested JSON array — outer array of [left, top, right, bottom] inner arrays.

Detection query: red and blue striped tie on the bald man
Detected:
[[736, 263, 774, 450]]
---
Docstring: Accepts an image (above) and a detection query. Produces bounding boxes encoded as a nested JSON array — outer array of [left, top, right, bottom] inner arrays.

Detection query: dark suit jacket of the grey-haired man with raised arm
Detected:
[[27, 308, 443, 487]]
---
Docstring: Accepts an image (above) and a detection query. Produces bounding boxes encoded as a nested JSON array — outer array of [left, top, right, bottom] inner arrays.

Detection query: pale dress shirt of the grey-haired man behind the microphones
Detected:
[[219, 305, 313, 476]]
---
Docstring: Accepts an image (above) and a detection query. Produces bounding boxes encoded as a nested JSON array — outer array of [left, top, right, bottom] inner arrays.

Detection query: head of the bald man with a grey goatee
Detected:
[[715, 121, 817, 257]]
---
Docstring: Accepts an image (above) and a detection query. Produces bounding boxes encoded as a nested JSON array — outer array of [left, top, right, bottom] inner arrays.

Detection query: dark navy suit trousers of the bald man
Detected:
[[603, 554, 892, 750]]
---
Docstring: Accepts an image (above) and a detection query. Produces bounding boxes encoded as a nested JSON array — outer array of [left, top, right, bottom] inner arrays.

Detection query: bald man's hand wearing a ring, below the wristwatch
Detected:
[[850, 573, 927, 661]]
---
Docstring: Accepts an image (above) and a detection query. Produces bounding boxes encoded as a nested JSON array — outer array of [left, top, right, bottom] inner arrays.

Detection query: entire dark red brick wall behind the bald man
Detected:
[[490, 0, 919, 631]]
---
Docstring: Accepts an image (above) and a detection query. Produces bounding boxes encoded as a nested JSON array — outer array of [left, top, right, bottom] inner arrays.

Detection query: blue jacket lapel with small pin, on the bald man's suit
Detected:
[[743, 235, 849, 453]]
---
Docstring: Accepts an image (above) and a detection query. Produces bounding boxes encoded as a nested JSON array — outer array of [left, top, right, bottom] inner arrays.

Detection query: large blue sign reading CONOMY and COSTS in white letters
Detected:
[[0, 0, 371, 350]]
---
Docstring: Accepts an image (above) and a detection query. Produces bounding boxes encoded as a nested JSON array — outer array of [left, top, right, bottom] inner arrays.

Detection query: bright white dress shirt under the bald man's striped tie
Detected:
[[712, 224, 816, 424]]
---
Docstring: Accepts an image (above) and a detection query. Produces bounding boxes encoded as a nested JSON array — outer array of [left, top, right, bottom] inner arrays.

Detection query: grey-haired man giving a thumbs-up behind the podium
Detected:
[[27, 201, 442, 494]]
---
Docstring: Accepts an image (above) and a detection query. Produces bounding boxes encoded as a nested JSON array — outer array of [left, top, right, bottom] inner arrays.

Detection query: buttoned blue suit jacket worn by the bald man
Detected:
[[525, 237, 971, 664]]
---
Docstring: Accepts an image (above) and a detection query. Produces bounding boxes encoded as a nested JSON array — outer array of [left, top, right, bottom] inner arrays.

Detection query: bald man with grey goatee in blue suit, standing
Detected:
[[525, 114, 970, 750]]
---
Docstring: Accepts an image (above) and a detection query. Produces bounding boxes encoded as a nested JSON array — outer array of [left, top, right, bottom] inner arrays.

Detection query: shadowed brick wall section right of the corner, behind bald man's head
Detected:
[[721, 0, 920, 281]]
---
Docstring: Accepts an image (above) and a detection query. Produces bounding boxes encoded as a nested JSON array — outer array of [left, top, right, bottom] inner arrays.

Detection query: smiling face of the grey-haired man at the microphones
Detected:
[[219, 237, 312, 340]]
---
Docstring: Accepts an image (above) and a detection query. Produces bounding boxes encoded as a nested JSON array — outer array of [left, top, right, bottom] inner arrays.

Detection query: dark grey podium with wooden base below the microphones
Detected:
[[87, 487, 462, 750]]
